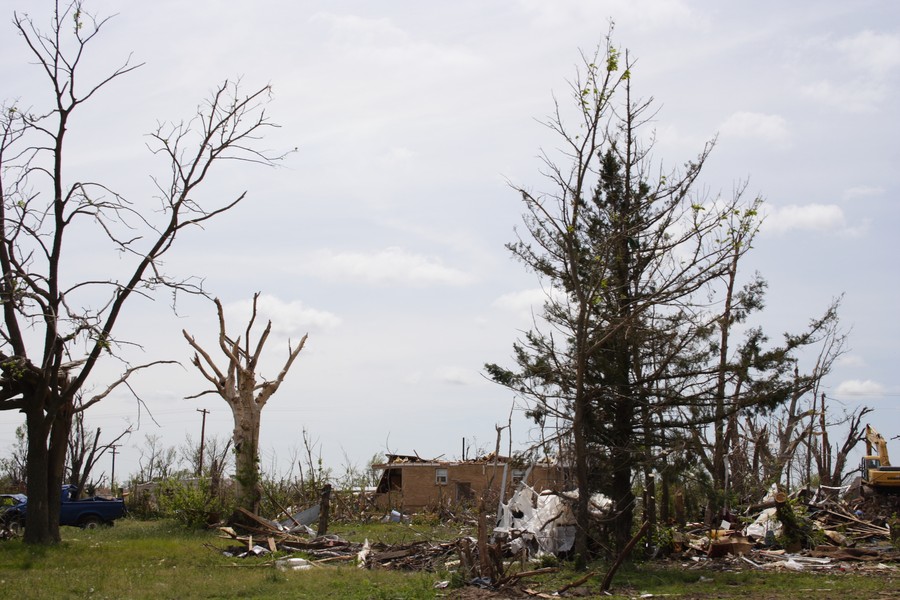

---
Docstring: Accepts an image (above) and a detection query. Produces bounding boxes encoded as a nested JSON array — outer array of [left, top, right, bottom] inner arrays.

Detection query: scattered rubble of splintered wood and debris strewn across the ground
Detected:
[[211, 485, 900, 597]]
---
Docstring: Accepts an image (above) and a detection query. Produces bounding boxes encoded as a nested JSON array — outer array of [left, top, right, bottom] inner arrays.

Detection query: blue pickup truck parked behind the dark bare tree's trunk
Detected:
[[0, 485, 125, 529]]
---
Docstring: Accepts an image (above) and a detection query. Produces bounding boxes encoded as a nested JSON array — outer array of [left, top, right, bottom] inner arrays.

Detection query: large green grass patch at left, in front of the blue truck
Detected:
[[0, 519, 438, 600]]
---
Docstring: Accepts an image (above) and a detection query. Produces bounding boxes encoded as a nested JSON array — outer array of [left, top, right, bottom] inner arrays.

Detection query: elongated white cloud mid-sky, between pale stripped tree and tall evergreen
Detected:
[[300, 247, 473, 286]]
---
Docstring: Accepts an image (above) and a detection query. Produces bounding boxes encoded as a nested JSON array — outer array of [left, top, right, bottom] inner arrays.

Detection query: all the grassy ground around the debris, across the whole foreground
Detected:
[[0, 519, 900, 600]]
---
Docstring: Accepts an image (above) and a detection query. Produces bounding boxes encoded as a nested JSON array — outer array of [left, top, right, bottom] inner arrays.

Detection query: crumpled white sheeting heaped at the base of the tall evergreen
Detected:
[[494, 485, 612, 556]]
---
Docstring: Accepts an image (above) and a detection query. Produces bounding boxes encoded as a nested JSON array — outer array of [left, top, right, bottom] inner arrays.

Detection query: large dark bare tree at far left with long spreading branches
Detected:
[[0, 0, 280, 544]]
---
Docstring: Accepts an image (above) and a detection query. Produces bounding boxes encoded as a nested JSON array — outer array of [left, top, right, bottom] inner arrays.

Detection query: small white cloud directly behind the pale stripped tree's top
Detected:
[[224, 294, 341, 338]]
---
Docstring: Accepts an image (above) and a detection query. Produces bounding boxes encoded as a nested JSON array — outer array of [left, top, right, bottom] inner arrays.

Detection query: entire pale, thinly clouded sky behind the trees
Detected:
[[0, 0, 900, 486]]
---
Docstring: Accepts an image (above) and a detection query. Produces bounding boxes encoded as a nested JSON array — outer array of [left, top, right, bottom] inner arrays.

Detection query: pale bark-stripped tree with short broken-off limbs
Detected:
[[183, 292, 307, 513]]
